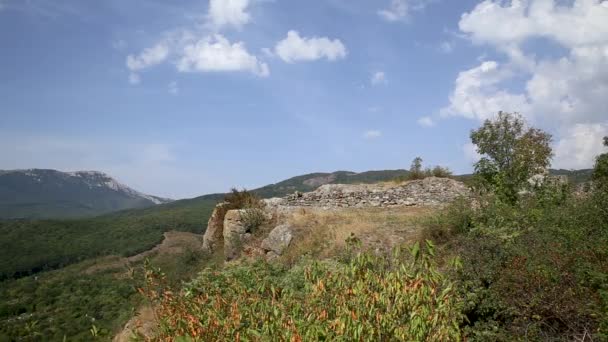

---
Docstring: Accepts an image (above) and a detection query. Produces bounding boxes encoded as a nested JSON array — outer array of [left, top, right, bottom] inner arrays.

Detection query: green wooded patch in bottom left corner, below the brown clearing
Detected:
[[0, 264, 141, 341]]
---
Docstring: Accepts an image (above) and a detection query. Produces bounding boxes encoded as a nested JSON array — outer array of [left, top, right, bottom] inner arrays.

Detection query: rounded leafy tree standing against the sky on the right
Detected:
[[471, 112, 553, 203]]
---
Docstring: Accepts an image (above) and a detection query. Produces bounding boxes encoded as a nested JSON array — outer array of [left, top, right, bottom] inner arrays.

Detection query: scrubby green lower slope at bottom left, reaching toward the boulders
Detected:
[[0, 233, 215, 341]]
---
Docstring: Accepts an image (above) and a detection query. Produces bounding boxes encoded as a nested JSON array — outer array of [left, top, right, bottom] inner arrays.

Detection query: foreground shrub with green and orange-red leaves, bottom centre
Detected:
[[143, 239, 463, 341]]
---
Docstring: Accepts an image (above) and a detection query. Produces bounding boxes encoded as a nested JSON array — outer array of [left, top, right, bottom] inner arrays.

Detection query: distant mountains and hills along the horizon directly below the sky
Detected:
[[0, 169, 591, 219]]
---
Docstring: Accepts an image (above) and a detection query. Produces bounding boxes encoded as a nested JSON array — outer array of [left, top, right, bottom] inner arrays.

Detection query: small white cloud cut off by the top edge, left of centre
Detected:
[[208, 0, 251, 28]]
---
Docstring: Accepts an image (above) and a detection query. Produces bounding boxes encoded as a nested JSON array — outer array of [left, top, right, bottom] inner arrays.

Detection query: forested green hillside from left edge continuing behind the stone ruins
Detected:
[[0, 166, 590, 280]]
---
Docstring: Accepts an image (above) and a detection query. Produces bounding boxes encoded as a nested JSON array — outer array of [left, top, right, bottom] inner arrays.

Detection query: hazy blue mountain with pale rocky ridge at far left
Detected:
[[0, 169, 171, 219]]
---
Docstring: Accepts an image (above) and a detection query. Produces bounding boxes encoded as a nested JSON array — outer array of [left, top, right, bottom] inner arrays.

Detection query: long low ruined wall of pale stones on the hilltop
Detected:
[[272, 177, 469, 208]]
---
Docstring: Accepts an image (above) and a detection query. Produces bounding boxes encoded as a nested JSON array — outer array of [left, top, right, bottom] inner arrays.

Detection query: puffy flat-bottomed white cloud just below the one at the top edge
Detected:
[[177, 34, 270, 77]]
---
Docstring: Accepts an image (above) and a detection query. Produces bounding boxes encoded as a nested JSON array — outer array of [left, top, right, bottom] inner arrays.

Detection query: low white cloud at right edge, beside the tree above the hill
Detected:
[[553, 122, 608, 169]]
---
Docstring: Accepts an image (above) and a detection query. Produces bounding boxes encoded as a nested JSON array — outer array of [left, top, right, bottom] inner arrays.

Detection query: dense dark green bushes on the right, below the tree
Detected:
[[427, 180, 608, 341]]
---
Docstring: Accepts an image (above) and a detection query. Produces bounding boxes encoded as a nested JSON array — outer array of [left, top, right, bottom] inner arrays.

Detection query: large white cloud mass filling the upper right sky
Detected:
[[440, 0, 608, 168]]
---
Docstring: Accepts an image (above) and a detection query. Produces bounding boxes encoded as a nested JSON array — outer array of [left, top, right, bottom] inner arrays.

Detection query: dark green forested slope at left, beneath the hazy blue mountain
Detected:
[[0, 199, 216, 280]]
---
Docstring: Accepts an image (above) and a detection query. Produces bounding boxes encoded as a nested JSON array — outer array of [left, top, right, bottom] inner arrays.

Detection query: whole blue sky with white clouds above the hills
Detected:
[[0, 0, 608, 198]]
